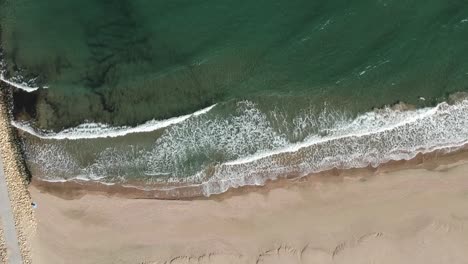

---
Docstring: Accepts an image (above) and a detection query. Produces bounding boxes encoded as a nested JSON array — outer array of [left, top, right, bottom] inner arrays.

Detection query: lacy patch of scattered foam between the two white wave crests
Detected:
[[146, 101, 289, 177]]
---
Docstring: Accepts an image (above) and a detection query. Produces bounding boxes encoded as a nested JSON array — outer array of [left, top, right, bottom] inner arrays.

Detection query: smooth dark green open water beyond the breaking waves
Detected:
[[0, 0, 468, 129]]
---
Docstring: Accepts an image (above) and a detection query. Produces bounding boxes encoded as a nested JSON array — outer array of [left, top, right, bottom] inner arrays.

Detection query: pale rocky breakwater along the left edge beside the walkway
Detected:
[[0, 83, 36, 263]]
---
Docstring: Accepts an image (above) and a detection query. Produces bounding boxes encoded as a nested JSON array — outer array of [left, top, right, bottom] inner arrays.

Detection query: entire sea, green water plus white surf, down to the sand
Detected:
[[0, 0, 468, 195]]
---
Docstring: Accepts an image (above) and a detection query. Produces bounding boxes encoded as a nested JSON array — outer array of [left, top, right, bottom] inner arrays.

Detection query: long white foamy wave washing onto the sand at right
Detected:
[[198, 100, 468, 196]]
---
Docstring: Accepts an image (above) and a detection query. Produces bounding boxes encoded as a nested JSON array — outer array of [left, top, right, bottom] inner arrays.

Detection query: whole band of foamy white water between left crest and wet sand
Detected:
[[22, 100, 468, 196]]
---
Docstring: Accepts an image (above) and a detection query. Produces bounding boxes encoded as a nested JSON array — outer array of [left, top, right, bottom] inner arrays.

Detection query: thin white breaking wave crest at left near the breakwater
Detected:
[[11, 104, 216, 140]]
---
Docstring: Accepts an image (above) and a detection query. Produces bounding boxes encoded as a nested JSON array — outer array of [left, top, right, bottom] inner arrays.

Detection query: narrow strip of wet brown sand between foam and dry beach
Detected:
[[31, 144, 468, 200]]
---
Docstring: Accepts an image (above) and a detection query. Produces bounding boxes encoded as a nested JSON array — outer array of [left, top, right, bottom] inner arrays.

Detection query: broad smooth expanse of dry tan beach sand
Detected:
[[30, 156, 468, 264]]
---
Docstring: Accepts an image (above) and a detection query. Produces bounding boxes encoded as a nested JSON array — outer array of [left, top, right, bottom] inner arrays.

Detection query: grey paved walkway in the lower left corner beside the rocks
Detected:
[[0, 158, 23, 264]]
